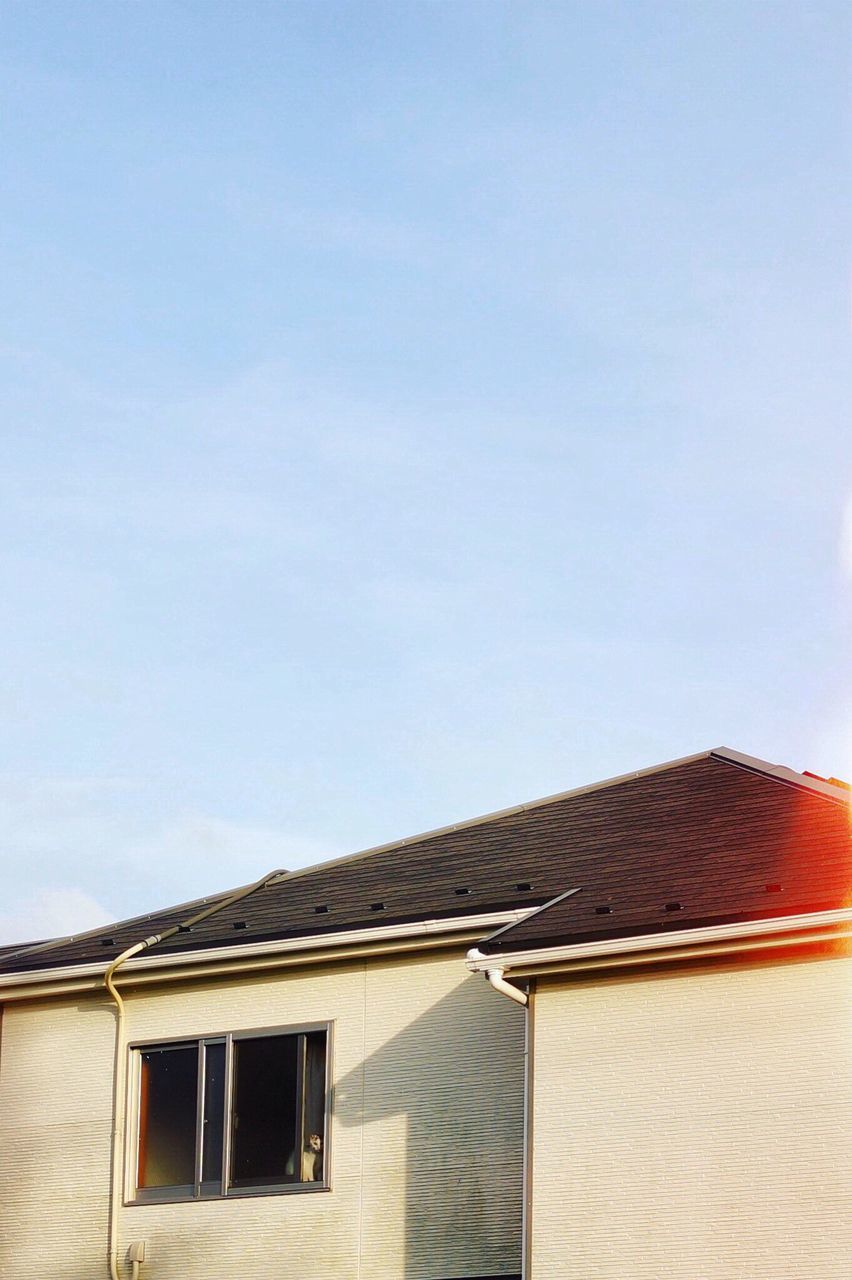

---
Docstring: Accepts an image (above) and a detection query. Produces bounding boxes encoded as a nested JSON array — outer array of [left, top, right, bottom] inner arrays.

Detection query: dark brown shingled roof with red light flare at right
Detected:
[[0, 749, 852, 972]]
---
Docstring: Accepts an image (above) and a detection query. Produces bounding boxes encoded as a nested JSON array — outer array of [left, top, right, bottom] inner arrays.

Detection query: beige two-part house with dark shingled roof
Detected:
[[0, 749, 852, 1280]]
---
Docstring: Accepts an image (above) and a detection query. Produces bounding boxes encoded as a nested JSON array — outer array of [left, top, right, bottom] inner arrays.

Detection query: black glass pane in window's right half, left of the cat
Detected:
[[230, 1036, 296, 1187]]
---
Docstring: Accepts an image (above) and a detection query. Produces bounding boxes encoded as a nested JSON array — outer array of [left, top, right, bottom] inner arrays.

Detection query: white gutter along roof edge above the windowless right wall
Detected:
[[467, 908, 852, 974]]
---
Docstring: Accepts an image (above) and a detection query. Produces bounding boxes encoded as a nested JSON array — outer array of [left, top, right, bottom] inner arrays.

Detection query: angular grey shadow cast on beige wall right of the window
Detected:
[[335, 975, 523, 1280]]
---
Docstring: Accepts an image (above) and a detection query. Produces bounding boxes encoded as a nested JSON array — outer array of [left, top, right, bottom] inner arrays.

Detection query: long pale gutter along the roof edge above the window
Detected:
[[0, 908, 535, 998]]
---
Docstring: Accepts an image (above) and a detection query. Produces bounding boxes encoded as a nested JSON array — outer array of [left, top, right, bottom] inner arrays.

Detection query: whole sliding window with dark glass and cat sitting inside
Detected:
[[132, 1027, 329, 1201]]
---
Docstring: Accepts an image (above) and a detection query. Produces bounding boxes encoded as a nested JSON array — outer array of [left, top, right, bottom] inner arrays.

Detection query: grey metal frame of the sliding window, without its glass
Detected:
[[124, 1021, 334, 1207]]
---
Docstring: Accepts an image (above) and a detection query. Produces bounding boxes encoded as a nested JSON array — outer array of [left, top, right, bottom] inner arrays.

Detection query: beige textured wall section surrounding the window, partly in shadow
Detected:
[[0, 951, 523, 1280]]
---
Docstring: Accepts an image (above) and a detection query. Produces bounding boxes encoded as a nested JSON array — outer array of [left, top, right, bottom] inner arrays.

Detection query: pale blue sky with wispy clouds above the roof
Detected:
[[0, 0, 852, 942]]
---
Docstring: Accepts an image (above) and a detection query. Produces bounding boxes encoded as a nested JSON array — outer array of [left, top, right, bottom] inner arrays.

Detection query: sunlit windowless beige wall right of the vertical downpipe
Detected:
[[531, 957, 852, 1280]]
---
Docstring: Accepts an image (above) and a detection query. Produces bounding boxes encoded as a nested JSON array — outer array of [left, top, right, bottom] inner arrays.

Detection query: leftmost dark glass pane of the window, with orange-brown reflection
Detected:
[[138, 1044, 198, 1188]]
